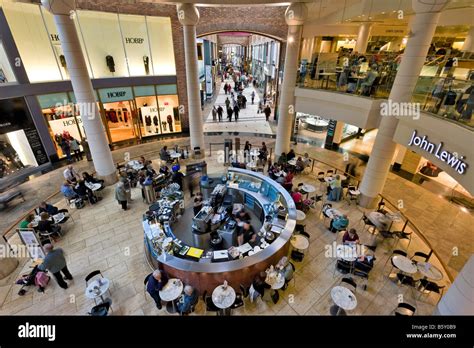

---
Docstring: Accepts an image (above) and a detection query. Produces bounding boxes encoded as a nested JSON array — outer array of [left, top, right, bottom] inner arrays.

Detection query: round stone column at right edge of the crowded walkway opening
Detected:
[[275, 3, 308, 159]]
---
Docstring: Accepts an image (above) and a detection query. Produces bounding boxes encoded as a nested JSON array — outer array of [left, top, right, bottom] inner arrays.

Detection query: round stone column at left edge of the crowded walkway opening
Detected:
[[177, 4, 204, 155]]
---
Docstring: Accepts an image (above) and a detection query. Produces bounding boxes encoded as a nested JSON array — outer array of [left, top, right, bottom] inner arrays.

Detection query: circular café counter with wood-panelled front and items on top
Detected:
[[143, 168, 296, 293]]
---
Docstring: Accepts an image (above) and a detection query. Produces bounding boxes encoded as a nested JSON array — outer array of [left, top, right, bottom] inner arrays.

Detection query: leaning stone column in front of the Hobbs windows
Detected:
[[41, 0, 117, 184]]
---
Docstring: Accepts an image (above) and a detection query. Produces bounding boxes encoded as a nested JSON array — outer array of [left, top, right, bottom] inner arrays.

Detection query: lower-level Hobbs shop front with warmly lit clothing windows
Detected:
[[38, 84, 182, 158]]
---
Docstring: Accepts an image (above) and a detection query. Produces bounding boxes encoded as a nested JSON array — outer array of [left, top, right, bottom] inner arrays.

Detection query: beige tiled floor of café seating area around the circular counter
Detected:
[[0, 152, 446, 315]]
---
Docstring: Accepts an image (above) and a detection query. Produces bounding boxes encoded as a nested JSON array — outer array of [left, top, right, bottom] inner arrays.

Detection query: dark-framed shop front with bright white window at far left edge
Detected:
[[0, 98, 49, 178]]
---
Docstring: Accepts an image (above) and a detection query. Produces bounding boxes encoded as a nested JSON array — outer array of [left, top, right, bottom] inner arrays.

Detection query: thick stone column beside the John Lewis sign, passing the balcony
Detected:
[[359, 0, 448, 207]]
